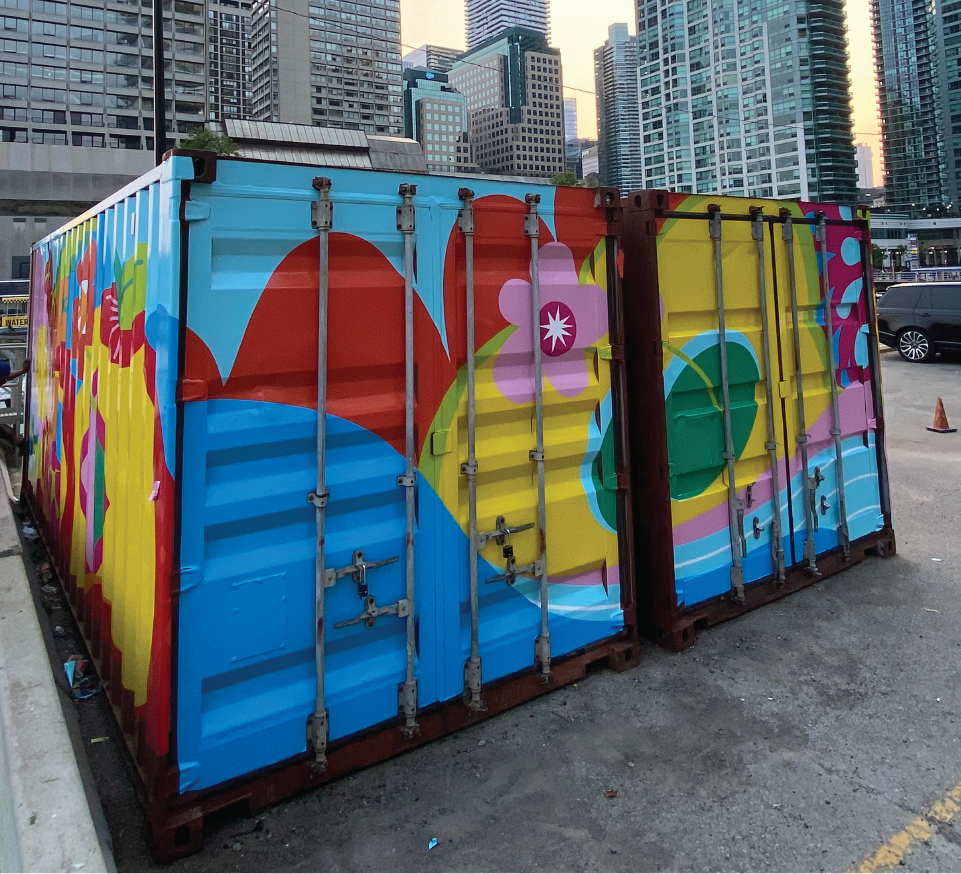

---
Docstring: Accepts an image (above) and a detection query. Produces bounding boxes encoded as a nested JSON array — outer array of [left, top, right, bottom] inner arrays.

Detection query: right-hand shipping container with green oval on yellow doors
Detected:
[[621, 191, 895, 649]]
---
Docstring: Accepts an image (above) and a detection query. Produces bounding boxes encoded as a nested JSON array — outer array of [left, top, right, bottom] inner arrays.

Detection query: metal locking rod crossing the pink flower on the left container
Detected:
[[524, 194, 551, 683]]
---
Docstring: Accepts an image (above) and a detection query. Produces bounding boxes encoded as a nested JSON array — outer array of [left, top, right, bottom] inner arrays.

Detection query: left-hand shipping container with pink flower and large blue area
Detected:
[[24, 152, 638, 859]]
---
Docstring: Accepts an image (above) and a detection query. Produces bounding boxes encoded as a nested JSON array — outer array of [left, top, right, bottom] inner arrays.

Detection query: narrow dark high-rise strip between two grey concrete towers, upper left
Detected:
[[207, 0, 253, 121]]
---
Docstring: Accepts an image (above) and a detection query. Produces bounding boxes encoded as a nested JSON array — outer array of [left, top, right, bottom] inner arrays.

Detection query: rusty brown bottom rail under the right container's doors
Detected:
[[643, 528, 897, 652]]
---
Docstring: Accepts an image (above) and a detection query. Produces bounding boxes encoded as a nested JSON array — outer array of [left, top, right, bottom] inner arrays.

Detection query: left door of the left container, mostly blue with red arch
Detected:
[[177, 162, 435, 791]]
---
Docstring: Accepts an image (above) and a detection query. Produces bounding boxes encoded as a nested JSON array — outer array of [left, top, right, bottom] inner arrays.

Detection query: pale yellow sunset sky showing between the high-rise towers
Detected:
[[400, 0, 880, 185]]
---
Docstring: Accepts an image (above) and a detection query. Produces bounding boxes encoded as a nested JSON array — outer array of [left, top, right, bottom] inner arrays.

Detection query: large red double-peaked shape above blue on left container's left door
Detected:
[[185, 233, 456, 464]]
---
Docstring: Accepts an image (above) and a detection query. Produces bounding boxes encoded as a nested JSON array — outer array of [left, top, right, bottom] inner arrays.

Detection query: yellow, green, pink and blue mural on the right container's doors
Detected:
[[658, 195, 882, 605]]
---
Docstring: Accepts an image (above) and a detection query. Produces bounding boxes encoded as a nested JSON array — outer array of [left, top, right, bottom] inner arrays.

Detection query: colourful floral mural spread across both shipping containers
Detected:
[[28, 157, 879, 792]]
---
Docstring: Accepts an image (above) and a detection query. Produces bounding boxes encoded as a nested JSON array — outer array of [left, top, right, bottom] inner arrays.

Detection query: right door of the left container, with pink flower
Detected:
[[418, 187, 632, 707]]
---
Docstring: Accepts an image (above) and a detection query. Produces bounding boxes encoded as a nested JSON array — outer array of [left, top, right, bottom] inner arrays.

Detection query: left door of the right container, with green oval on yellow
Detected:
[[658, 195, 790, 606]]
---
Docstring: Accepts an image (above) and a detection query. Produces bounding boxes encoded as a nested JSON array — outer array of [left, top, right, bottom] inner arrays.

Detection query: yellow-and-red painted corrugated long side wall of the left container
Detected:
[[25, 158, 193, 770]]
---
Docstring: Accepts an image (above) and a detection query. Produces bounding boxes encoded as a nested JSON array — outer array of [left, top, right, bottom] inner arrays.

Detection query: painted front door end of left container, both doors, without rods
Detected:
[[177, 161, 625, 791]]
